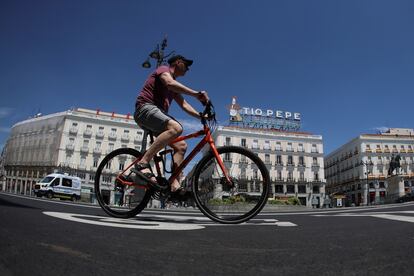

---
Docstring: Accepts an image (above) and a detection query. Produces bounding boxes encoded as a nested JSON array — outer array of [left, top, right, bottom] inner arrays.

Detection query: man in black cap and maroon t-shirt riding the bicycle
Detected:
[[134, 55, 209, 193]]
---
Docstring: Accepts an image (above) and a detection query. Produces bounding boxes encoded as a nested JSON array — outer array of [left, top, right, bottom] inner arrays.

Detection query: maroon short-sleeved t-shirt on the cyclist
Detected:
[[135, 65, 174, 112]]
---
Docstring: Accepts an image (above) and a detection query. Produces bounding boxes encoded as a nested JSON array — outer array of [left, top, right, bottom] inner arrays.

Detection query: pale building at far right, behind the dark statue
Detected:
[[325, 128, 414, 206]]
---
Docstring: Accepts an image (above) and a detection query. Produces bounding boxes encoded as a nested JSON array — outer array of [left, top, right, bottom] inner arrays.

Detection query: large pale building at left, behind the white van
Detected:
[[3, 108, 143, 201]]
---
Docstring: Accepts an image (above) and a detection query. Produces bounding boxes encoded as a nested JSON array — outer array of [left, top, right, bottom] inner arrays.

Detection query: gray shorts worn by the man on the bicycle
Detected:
[[134, 104, 179, 136]]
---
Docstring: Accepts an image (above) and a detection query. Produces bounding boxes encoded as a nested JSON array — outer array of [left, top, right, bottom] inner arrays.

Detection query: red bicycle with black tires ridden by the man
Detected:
[[95, 102, 270, 223]]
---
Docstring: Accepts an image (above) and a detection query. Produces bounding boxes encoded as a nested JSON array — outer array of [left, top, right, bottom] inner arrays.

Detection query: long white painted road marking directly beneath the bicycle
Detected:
[[43, 211, 297, 231]]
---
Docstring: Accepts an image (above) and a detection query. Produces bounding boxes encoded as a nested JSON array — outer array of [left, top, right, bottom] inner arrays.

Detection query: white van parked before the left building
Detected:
[[33, 173, 81, 201]]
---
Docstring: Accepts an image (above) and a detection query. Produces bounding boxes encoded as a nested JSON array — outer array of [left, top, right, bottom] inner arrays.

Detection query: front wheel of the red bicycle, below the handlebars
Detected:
[[193, 146, 270, 223]]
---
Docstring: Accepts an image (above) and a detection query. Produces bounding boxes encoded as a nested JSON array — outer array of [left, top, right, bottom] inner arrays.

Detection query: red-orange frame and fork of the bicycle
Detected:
[[117, 125, 231, 188]]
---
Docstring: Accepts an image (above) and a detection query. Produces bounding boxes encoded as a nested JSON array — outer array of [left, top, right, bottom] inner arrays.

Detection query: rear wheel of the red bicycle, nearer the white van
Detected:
[[95, 148, 152, 218]]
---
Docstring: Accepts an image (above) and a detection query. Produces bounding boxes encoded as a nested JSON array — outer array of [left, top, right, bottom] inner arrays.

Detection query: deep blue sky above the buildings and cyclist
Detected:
[[0, 0, 414, 153]]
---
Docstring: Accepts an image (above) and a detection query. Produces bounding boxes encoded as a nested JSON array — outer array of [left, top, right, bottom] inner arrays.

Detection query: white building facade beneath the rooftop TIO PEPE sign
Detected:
[[213, 126, 326, 207]]
